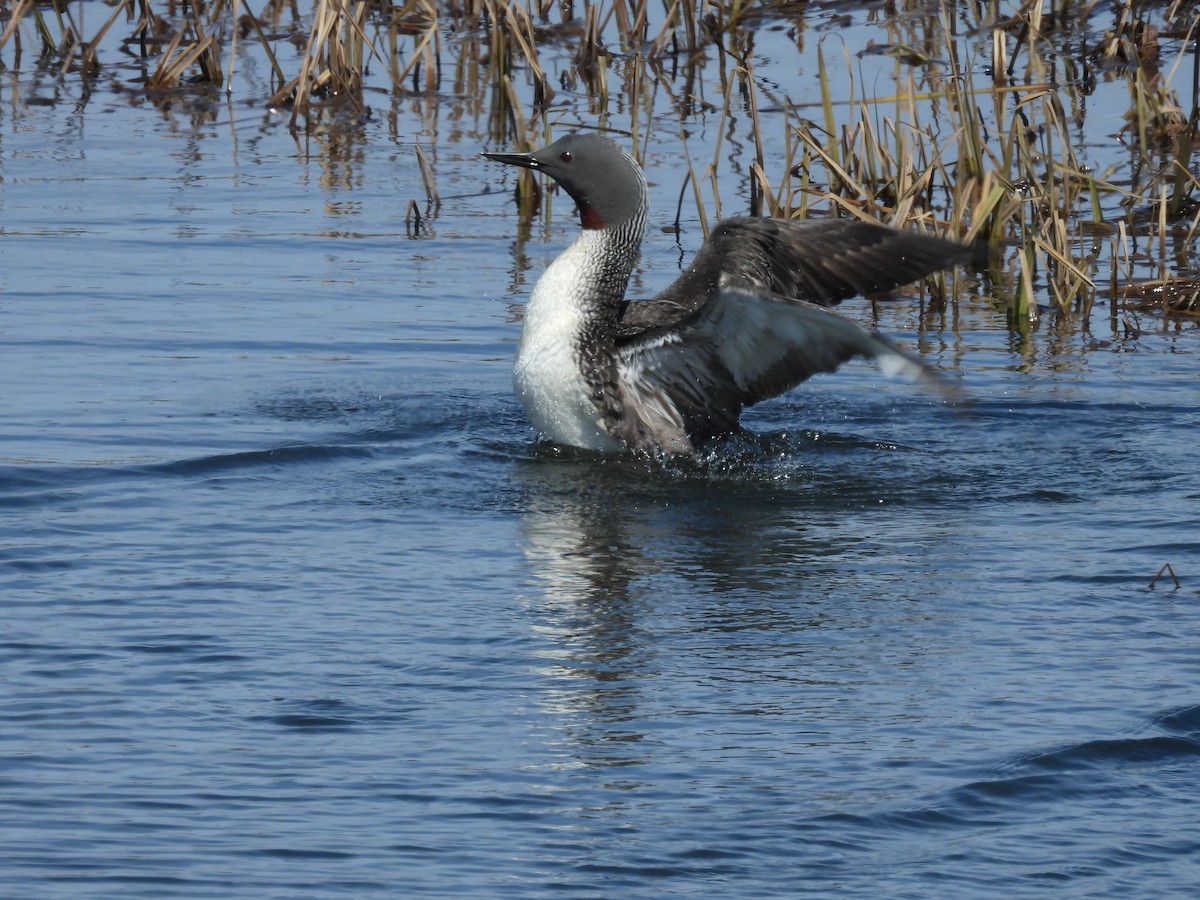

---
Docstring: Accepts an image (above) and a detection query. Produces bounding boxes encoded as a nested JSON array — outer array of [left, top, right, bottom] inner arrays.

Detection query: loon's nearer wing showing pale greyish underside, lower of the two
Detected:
[[618, 278, 937, 451]]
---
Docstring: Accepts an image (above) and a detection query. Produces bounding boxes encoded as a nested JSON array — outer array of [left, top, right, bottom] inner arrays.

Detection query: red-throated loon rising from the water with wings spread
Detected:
[[484, 133, 972, 454]]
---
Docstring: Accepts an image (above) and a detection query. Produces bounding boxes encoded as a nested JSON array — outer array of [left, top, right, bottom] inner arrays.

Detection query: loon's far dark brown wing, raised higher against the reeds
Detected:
[[617, 217, 974, 344]]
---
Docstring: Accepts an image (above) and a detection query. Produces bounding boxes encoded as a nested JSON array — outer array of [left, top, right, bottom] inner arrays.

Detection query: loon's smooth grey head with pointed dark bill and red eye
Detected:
[[484, 133, 646, 234]]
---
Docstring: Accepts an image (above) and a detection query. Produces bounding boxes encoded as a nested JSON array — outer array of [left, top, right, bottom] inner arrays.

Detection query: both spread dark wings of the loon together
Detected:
[[611, 212, 976, 452]]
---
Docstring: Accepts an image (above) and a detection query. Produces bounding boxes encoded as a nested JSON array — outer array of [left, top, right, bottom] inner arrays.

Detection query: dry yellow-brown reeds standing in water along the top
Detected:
[[0, 0, 1200, 332]]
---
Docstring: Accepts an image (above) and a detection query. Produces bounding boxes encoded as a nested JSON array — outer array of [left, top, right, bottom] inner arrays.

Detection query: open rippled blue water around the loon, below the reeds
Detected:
[[0, 5, 1200, 898]]
